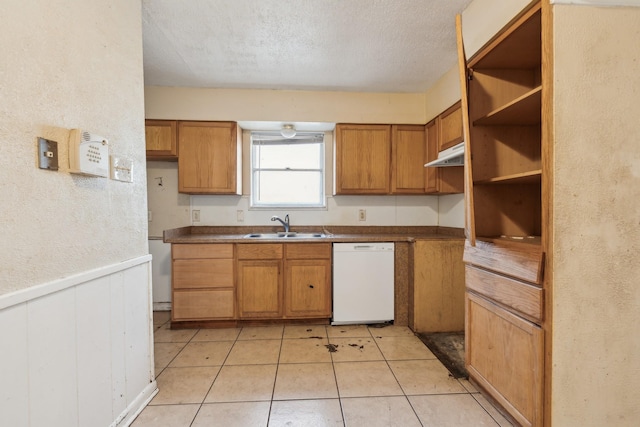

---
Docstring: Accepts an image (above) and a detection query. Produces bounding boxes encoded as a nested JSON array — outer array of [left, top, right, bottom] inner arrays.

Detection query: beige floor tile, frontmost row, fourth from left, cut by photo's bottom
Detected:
[[342, 396, 422, 427]]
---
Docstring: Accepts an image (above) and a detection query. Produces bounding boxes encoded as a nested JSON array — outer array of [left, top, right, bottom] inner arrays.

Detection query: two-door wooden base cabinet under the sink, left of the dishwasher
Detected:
[[237, 243, 331, 319]]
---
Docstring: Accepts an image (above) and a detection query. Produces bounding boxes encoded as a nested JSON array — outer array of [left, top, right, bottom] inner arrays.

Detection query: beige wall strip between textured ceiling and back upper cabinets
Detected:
[[145, 86, 425, 124]]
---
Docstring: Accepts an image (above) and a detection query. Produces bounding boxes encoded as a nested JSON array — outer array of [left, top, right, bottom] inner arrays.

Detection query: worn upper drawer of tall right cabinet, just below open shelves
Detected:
[[464, 240, 544, 285]]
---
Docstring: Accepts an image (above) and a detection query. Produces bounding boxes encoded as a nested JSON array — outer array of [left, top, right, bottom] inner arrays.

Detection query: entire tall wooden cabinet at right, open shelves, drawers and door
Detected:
[[457, 2, 548, 426]]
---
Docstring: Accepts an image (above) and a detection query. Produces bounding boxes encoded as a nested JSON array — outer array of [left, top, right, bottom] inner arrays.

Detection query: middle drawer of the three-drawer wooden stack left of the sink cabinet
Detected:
[[173, 259, 233, 289]]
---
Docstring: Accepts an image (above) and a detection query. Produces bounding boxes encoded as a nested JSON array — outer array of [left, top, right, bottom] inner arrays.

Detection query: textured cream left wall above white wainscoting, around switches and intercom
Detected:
[[0, 0, 147, 294]]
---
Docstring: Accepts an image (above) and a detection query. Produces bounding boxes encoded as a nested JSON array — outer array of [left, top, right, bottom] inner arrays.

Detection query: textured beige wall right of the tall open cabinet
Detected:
[[552, 5, 640, 427]]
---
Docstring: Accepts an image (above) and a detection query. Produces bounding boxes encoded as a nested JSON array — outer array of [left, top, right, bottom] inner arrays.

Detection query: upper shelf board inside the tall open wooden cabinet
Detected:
[[473, 86, 542, 126]]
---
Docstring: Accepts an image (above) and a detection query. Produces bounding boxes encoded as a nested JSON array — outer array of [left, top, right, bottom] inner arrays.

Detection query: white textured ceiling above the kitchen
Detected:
[[142, 0, 471, 93]]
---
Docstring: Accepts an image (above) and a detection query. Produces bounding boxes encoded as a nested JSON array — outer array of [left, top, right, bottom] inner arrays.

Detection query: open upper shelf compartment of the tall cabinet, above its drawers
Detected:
[[464, 4, 542, 244]]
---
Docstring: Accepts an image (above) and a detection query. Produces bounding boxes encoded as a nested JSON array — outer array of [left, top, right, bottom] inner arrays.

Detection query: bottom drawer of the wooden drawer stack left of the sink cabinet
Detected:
[[171, 289, 234, 320]]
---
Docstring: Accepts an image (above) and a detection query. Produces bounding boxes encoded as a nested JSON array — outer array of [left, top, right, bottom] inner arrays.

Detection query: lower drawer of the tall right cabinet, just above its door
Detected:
[[465, 265, 544, 323]]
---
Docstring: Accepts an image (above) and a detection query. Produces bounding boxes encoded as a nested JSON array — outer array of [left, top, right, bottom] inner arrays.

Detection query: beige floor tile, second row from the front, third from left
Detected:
[[273, 363, 338, 400]]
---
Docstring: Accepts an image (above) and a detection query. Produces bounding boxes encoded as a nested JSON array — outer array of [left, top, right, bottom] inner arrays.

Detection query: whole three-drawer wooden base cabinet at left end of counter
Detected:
[[171, 244, 235, 321]]
